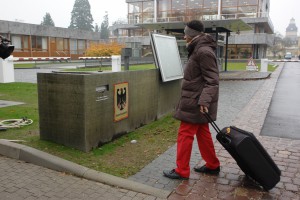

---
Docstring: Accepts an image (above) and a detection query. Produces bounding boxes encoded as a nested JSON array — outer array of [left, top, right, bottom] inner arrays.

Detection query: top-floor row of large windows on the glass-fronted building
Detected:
[[127, 0, 263, 24]]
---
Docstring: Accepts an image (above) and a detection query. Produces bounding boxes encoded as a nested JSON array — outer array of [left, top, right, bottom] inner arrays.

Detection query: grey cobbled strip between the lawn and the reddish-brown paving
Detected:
[[129, 75, 269, 191]]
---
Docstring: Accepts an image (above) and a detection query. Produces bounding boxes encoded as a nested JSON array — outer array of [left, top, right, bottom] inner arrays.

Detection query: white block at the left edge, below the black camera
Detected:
[[0, 56, 15, 83]]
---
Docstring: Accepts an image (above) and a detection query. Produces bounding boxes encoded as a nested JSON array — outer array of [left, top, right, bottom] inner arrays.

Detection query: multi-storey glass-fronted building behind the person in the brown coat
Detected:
[[111, 0, 274, 59]]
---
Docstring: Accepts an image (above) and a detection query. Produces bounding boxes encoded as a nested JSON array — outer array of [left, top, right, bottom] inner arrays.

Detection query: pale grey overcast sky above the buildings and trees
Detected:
[[0, 0, 300, 36]]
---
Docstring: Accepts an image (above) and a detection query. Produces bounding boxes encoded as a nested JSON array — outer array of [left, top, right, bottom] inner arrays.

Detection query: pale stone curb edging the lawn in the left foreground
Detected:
[[0, 139, 172, 199]]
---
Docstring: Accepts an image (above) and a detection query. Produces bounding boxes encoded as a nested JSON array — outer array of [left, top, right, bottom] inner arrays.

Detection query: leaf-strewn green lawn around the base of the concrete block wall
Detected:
[[0, 83, 179, 178]]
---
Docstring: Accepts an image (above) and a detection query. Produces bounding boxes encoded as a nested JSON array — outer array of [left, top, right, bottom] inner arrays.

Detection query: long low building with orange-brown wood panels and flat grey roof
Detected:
[[0, 20, 105, 59]]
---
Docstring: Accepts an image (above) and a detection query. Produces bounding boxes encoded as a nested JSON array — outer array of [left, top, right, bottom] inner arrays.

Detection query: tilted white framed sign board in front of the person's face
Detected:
[[151, 33, 183, 82]]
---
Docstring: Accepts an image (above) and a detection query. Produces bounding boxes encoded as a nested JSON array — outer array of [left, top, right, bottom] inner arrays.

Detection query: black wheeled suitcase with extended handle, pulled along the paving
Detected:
[[205, 113, 281, 190]]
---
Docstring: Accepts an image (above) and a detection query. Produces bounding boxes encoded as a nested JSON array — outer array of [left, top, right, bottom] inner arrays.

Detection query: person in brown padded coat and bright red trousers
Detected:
[[163, 20, 220, 179]]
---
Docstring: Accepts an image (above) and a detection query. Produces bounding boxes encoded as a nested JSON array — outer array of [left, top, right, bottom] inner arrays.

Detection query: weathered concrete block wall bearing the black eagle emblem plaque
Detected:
[[37, 69, 181, 152]]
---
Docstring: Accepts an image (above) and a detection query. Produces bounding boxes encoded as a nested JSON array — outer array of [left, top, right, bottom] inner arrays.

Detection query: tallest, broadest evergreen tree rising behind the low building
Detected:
[[69, 0, 94, 31]]
